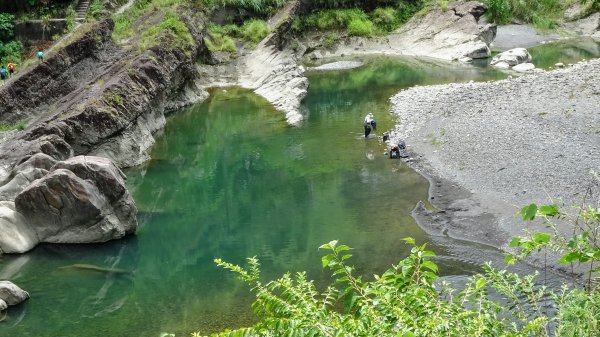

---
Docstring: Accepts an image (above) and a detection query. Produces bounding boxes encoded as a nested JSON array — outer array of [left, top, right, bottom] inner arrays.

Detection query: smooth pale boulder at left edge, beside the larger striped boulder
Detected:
[[0, 201, 39, 254]]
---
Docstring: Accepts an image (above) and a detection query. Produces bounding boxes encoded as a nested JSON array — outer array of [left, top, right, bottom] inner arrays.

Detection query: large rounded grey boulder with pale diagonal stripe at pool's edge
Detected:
[[15, 156, 137, 243]]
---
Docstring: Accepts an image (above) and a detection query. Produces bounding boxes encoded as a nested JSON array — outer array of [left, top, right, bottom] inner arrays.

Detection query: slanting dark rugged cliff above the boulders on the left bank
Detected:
[[0, 9, 209, 176]]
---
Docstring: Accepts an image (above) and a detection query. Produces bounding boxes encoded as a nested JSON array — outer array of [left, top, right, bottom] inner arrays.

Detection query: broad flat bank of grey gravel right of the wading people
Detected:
[[391, 60, 600, 247]]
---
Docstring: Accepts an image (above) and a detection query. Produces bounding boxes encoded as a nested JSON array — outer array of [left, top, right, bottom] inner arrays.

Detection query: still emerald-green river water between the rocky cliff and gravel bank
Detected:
[[0, 38, 599, 337]]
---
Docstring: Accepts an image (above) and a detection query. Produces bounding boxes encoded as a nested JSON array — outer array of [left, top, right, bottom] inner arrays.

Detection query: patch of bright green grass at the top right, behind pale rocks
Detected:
[[485, 0, 564, 29]]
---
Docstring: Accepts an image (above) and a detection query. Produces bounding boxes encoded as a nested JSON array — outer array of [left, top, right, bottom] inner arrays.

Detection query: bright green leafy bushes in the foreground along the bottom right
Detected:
[[203, 194, 600, 337]]
